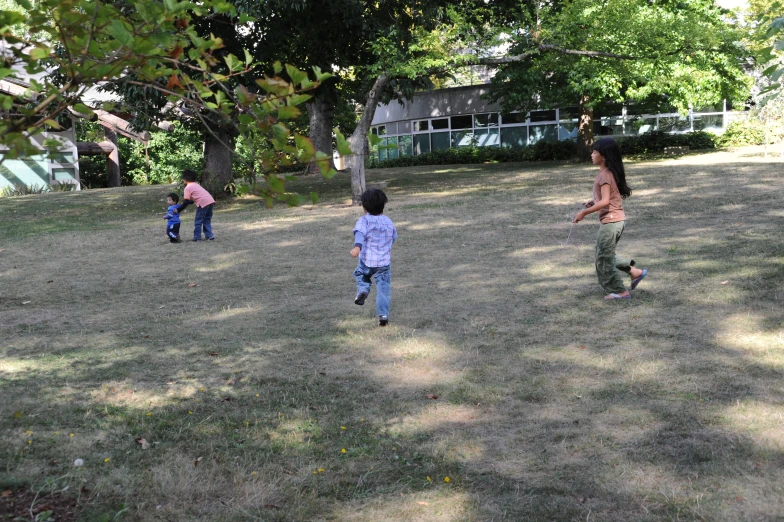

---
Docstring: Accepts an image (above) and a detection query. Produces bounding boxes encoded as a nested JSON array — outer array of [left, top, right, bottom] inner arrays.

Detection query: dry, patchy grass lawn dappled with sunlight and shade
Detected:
[[0, 151, 784, 521]]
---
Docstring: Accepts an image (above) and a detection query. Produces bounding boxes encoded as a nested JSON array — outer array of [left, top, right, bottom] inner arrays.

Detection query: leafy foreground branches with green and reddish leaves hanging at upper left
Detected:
[[0, 0, 331, 203]]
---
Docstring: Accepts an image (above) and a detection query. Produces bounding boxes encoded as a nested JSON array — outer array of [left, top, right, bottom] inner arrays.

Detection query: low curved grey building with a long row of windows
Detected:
[[371, 85, 745, 160]]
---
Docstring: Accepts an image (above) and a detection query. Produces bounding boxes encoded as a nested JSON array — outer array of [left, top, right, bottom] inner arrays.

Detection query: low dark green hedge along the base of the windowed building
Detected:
[[367, 131, 721, 169]]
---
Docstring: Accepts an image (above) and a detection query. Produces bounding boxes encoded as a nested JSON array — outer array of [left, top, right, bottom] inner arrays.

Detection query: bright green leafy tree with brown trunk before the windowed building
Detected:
[[491, 0, 751, 156]]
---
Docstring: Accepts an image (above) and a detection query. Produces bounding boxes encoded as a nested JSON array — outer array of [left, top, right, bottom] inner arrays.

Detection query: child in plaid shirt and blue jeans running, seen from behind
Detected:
[[350, 189, 397, 326]]
